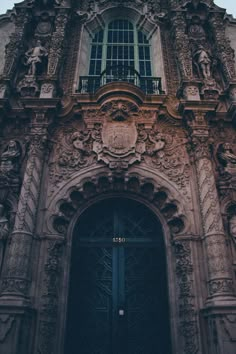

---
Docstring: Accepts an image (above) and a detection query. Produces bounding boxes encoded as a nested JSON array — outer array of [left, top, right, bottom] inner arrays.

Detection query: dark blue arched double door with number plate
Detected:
[[65, 198, 171, 354]]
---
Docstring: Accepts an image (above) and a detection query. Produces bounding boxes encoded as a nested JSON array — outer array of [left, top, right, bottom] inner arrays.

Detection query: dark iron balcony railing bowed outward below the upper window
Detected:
[[78, 66, 164, 95]]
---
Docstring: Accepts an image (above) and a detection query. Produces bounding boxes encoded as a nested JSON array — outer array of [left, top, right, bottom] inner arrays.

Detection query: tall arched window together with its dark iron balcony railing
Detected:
[[79, 19, 163, 94]]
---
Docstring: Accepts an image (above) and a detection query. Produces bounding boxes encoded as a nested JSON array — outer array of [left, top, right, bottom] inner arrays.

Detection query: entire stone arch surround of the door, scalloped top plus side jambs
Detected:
[[42, 166, 193, 354]]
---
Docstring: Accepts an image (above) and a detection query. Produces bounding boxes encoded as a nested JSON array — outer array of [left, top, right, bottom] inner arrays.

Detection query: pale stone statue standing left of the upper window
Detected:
[[25, 40, 48, 76]]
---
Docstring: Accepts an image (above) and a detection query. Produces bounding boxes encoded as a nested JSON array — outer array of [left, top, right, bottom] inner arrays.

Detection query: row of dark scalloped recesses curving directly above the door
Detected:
[[53, 175, 185, 236]]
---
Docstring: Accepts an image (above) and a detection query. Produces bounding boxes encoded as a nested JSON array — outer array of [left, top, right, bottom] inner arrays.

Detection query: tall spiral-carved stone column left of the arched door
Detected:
[[0, 112, 48, 301]]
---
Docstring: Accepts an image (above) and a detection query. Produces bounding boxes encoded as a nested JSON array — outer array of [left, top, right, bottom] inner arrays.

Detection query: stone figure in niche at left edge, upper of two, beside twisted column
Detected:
[[0, 140, 21, 182]]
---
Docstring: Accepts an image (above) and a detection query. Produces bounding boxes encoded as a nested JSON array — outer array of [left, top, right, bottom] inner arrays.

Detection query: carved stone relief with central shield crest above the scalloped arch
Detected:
[[50, 100, 190, 197]]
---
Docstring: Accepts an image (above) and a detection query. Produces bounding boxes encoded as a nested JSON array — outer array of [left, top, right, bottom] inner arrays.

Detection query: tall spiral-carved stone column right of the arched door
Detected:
[[191, 112, 236, 305]]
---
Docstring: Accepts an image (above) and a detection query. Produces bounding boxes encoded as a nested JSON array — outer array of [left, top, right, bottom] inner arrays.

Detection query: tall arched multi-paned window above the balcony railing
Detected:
[[89, 19, 152, 79]]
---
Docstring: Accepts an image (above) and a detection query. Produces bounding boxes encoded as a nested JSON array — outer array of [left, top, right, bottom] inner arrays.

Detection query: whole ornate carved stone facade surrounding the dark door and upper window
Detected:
[[0, 0, 236, 354]]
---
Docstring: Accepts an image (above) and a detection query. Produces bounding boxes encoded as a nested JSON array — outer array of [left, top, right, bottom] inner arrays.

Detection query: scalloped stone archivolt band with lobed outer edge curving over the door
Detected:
[[48, 171, 191, 236]]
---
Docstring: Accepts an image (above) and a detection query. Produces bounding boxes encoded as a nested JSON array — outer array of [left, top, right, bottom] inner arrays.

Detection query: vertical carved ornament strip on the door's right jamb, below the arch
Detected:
[[173, 241, 198, 354]]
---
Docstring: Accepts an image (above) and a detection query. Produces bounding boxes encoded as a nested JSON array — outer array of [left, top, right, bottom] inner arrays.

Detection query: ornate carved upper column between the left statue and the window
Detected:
[[47, 10, 68, 76]]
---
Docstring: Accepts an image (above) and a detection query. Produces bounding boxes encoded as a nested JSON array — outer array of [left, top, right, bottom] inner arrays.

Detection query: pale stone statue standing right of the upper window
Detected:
[[194, 45, 212, 80]]
